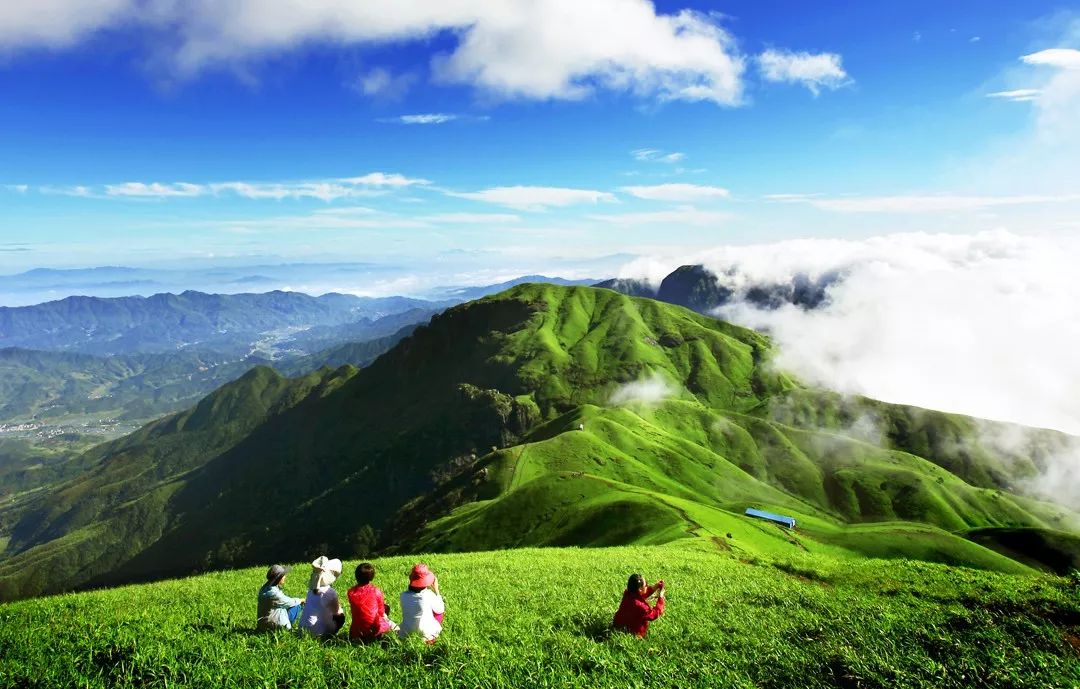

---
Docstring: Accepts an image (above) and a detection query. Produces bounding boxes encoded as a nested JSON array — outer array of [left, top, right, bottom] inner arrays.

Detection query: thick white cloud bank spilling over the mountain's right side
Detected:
[[620, 231, 1080, 434]]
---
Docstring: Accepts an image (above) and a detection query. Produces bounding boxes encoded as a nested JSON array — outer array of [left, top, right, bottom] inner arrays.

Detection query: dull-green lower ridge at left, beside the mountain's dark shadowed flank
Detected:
[[0, 367, 355, 597]]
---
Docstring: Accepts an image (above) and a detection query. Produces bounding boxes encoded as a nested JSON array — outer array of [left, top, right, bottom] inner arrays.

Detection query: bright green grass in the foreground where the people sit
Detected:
[[0, 540, 1080, 689]]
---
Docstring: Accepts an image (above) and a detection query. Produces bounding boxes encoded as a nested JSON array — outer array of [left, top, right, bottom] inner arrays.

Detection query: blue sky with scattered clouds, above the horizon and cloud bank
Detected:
[[0, 0, 1080, 282]]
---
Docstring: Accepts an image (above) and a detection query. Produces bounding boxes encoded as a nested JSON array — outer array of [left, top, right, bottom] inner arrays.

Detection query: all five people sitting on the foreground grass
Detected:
[[257, 555, 664, 644]]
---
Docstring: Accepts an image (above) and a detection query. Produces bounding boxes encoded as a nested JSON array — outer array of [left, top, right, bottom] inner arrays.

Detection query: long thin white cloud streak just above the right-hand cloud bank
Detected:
[[781, 193, 1080, 213]]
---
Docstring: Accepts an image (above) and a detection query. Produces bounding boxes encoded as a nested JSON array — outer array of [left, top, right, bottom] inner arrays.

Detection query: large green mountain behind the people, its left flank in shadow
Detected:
[[0, 285, 1077, 596]]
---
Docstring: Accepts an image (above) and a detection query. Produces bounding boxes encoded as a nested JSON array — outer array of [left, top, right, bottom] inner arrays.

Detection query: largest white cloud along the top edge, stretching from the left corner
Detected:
[[0, 0, 743, 105]]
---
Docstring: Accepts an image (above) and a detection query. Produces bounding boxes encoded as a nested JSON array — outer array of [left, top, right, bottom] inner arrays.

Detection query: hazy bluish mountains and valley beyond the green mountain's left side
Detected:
[[0, 278, 600, 509]]
